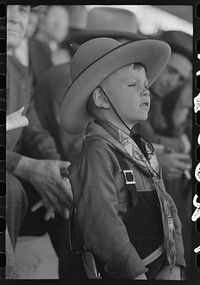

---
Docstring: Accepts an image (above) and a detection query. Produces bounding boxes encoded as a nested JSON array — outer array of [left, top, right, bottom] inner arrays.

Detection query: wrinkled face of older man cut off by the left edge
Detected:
[[7, 5, 30, 48]]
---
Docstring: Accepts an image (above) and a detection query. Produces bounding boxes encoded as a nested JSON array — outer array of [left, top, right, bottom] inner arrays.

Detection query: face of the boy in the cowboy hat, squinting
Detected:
[[101, 65, 150, 126]]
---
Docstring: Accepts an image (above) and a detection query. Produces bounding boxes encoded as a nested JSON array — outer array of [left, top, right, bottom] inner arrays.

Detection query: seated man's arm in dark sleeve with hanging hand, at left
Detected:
[[7, 90, 72, 217]]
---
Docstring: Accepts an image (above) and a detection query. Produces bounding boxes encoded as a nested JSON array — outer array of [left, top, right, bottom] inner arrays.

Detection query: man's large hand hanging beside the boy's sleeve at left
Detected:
[[14, 157, 73, 218]]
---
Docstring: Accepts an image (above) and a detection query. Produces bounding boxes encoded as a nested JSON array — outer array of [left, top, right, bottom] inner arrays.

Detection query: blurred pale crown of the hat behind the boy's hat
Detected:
[[86, 7, 138, 33]]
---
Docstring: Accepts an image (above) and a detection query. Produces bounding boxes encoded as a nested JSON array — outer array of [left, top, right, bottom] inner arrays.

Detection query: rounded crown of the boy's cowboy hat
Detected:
[[71, 38, 120, 80]]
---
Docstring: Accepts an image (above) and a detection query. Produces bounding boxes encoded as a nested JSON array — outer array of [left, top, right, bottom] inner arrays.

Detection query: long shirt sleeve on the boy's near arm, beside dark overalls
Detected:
[[70, 145, 147, 279]]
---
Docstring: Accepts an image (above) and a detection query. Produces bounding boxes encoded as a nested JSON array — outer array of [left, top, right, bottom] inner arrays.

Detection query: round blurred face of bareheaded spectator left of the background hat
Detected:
[[44, 6, 69, 43]]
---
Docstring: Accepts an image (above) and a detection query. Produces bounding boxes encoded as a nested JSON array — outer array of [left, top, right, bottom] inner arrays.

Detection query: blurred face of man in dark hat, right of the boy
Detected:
[[152, 52, 192, 97]]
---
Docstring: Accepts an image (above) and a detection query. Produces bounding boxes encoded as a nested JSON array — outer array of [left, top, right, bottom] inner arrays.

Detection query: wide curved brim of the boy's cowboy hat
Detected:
[[60, 39, 171, 134]]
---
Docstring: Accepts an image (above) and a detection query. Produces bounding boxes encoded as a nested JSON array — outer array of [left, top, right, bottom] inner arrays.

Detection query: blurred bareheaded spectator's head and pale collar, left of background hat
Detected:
[[35, 5, 71, 65]]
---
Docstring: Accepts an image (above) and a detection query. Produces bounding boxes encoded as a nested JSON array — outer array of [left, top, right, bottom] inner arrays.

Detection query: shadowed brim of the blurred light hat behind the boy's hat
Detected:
[[69, 30, 149, 44]]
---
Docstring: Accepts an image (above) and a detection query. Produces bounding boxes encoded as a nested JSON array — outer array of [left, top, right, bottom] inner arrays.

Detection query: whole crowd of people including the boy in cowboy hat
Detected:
[[6, 5, 193, 280]]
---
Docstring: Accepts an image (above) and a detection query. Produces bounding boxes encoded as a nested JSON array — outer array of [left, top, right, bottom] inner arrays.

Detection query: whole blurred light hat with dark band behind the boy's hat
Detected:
[[69, 7, 145, 44]]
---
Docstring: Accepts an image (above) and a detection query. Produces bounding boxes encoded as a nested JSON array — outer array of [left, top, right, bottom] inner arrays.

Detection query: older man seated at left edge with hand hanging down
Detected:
[[6, 5, 72, 278]]
